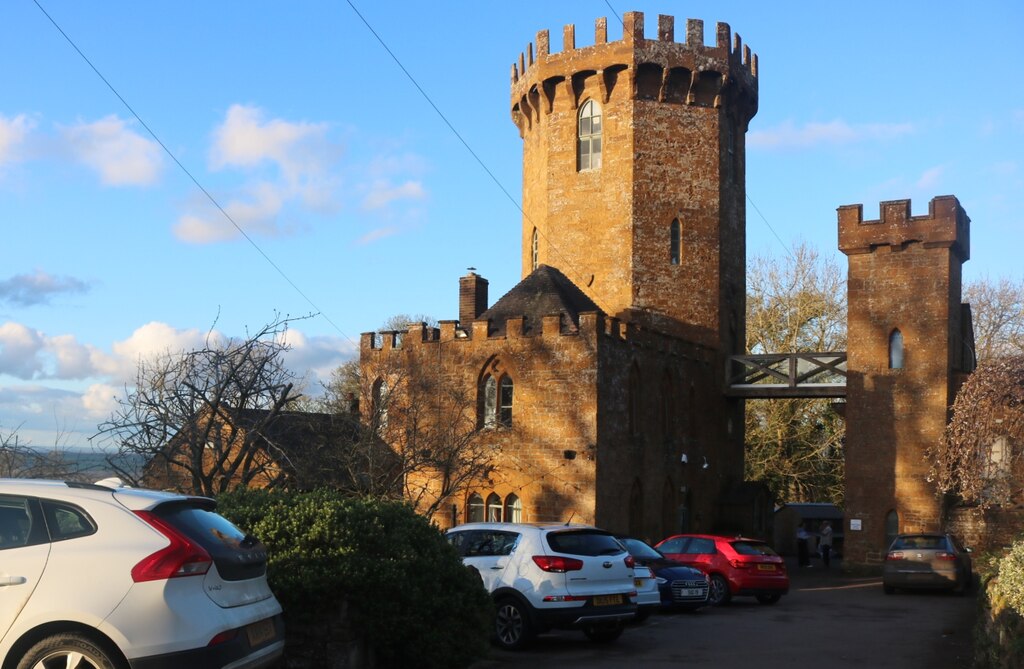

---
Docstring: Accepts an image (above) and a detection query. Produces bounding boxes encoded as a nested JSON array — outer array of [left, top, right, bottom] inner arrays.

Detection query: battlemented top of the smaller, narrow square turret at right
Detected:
[[837, 195, 971, 262]]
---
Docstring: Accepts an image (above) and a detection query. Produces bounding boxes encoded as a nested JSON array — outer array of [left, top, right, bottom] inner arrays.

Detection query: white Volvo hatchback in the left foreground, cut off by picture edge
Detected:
[[0, 478, 285, 669]]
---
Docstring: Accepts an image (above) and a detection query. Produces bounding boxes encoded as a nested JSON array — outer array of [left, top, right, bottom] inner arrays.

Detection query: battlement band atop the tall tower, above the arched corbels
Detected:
[[512, 11, 758, 100]]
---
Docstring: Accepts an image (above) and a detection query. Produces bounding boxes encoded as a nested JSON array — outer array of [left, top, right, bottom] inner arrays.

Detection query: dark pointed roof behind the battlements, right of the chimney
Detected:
[[479, 264, 601, 335]]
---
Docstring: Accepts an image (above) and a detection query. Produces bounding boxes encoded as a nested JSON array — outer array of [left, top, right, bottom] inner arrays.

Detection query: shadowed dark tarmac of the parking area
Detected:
[[474, 562, 976, 669]]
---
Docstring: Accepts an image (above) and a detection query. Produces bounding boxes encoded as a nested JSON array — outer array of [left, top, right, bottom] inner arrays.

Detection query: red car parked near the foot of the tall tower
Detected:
[[655, 534, 790, 605]]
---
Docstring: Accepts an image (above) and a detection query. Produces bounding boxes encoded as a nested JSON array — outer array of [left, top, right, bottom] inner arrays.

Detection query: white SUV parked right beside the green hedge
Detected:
[[446, 522, 637, 650]]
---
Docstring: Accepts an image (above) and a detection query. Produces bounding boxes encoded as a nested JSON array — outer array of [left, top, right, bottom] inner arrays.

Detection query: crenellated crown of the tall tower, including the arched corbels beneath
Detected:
[[512, 11, 758, 131]]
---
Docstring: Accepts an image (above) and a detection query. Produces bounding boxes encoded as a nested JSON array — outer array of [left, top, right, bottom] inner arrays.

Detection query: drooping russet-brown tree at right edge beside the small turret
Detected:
[[927, 356, 1024, 508]]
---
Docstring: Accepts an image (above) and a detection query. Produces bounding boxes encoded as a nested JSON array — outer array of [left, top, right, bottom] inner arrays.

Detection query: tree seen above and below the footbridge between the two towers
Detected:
[[745, 245, 846, 503]]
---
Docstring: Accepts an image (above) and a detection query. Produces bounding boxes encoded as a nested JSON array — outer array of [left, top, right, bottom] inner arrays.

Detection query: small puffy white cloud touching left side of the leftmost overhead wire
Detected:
[[62, 116, 163, 185]]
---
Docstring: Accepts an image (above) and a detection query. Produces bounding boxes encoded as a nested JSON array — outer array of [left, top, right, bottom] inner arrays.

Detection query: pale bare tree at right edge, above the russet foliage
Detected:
[[964, 277, 1024, 362]]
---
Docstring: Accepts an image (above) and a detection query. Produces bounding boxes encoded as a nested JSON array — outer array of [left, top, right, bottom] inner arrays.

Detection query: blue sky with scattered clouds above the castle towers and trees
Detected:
[[0, 0, 1024, 447]]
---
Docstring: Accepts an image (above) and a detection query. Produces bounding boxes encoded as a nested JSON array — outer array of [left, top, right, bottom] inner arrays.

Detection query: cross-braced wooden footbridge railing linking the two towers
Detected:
[[726, 351, 846, 399]]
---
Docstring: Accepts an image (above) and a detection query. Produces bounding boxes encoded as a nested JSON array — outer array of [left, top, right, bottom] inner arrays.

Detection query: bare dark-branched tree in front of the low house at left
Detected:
[[96, 317, 307, 496]]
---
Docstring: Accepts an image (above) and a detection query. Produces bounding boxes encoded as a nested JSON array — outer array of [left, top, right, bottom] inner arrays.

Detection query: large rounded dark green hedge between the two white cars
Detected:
[[217, 490, 494, 668]]
